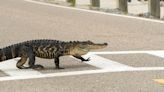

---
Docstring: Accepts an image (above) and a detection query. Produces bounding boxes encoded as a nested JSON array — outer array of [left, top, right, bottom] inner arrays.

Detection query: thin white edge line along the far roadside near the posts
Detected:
[[24, 0, 164, 24]]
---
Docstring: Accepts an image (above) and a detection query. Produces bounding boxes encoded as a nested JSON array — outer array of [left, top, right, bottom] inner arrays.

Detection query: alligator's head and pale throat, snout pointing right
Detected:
[[70, 41, 108, 55]]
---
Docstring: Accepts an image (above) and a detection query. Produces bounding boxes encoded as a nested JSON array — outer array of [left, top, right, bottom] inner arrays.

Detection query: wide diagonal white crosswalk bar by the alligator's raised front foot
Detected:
[[84, 54, 133, 70]]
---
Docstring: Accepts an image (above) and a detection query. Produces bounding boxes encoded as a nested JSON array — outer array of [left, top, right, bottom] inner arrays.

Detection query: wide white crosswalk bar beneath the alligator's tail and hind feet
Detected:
[[0, 58, 41, 76]]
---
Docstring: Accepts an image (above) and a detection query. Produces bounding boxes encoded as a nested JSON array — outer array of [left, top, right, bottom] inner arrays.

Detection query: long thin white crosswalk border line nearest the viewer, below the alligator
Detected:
[[0, 67, 164, 81]]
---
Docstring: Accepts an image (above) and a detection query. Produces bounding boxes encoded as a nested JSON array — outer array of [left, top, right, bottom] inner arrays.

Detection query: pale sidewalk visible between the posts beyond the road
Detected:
[[35, 0, 164, 19]]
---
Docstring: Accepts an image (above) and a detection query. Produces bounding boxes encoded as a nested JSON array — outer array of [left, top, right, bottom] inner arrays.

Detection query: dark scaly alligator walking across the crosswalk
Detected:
[[0, 39, 107, 69]]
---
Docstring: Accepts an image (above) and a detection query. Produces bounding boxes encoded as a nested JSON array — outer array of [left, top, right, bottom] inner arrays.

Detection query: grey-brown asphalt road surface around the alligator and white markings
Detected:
[[0, 0, 164, 92]]
